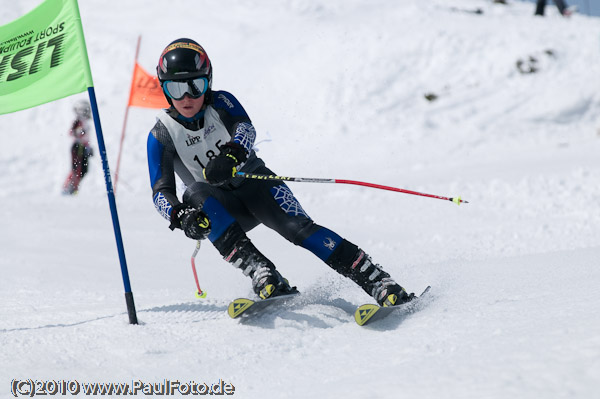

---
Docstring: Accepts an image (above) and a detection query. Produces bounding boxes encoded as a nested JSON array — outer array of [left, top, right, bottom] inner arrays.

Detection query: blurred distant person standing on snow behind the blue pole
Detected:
[[63, 100, 93, 195]]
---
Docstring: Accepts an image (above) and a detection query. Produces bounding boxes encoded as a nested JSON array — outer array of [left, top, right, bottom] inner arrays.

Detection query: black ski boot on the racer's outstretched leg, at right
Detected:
[[327, 240, 415, 306]]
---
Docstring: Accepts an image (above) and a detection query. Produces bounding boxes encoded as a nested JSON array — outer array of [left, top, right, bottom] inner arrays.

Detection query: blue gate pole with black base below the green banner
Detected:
[[88, 87, 138, 324]]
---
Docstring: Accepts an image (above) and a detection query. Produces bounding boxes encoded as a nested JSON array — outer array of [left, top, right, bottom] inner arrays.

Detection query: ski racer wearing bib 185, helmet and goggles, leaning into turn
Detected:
[[147, 38, 414, 306]]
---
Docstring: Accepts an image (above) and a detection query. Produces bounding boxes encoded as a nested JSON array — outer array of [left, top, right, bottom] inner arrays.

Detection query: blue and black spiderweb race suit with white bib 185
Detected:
[[148, 91, 345, 262]]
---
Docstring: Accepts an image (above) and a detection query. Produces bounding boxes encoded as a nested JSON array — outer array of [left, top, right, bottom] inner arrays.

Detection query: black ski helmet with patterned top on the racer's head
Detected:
[[156, 38, 212, 104]]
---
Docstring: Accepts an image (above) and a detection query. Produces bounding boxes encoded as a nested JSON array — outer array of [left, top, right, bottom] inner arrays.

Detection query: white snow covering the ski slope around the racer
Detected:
[[0, 0, 600, 398]]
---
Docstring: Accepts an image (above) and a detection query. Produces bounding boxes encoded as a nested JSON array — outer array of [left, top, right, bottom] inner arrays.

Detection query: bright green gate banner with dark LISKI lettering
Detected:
[[0, 0, 93, 114]]
